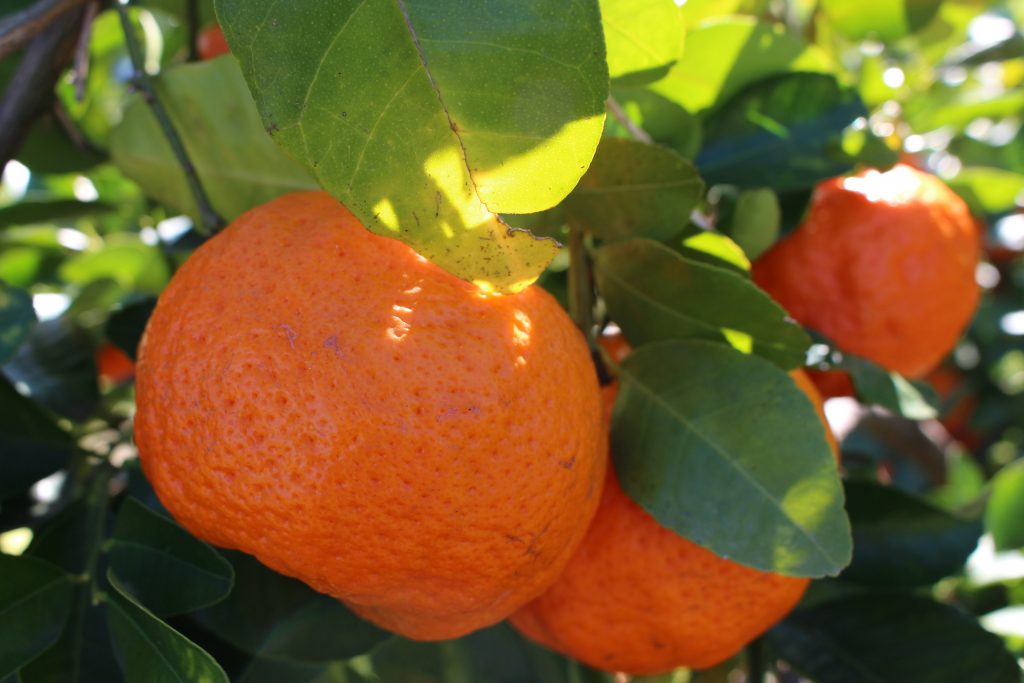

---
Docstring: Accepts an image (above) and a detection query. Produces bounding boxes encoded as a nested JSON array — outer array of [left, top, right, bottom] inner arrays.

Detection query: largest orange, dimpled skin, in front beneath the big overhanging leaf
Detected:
[[135, 193, 607, 640]]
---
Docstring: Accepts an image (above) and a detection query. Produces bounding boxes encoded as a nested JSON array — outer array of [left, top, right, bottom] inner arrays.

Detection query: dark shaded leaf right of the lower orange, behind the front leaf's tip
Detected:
[[841, 481, 981, 588]]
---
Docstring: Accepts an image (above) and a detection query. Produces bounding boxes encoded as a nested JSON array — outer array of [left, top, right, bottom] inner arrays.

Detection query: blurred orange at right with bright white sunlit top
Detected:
[[753, 164, 980, 378]]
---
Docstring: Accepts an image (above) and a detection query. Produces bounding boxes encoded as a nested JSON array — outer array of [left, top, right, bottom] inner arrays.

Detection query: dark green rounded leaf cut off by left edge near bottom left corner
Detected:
[[0, 555, 73, 678]]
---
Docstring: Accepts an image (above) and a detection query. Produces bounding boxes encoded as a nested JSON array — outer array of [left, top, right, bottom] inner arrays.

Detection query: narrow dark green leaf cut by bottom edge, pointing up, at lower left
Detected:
[[103, 572, 228, 683]]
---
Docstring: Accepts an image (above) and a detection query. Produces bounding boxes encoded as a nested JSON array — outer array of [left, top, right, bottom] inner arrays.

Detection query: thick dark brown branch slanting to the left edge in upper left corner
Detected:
[[0, 3, 82, 168]]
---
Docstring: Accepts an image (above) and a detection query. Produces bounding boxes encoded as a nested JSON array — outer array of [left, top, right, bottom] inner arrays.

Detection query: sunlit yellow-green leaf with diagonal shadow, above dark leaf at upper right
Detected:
[[651, 16, 833, 113]]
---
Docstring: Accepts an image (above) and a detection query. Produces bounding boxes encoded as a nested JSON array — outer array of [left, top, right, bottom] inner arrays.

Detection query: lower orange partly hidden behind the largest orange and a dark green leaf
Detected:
[[510, 368, 836, 676]]
